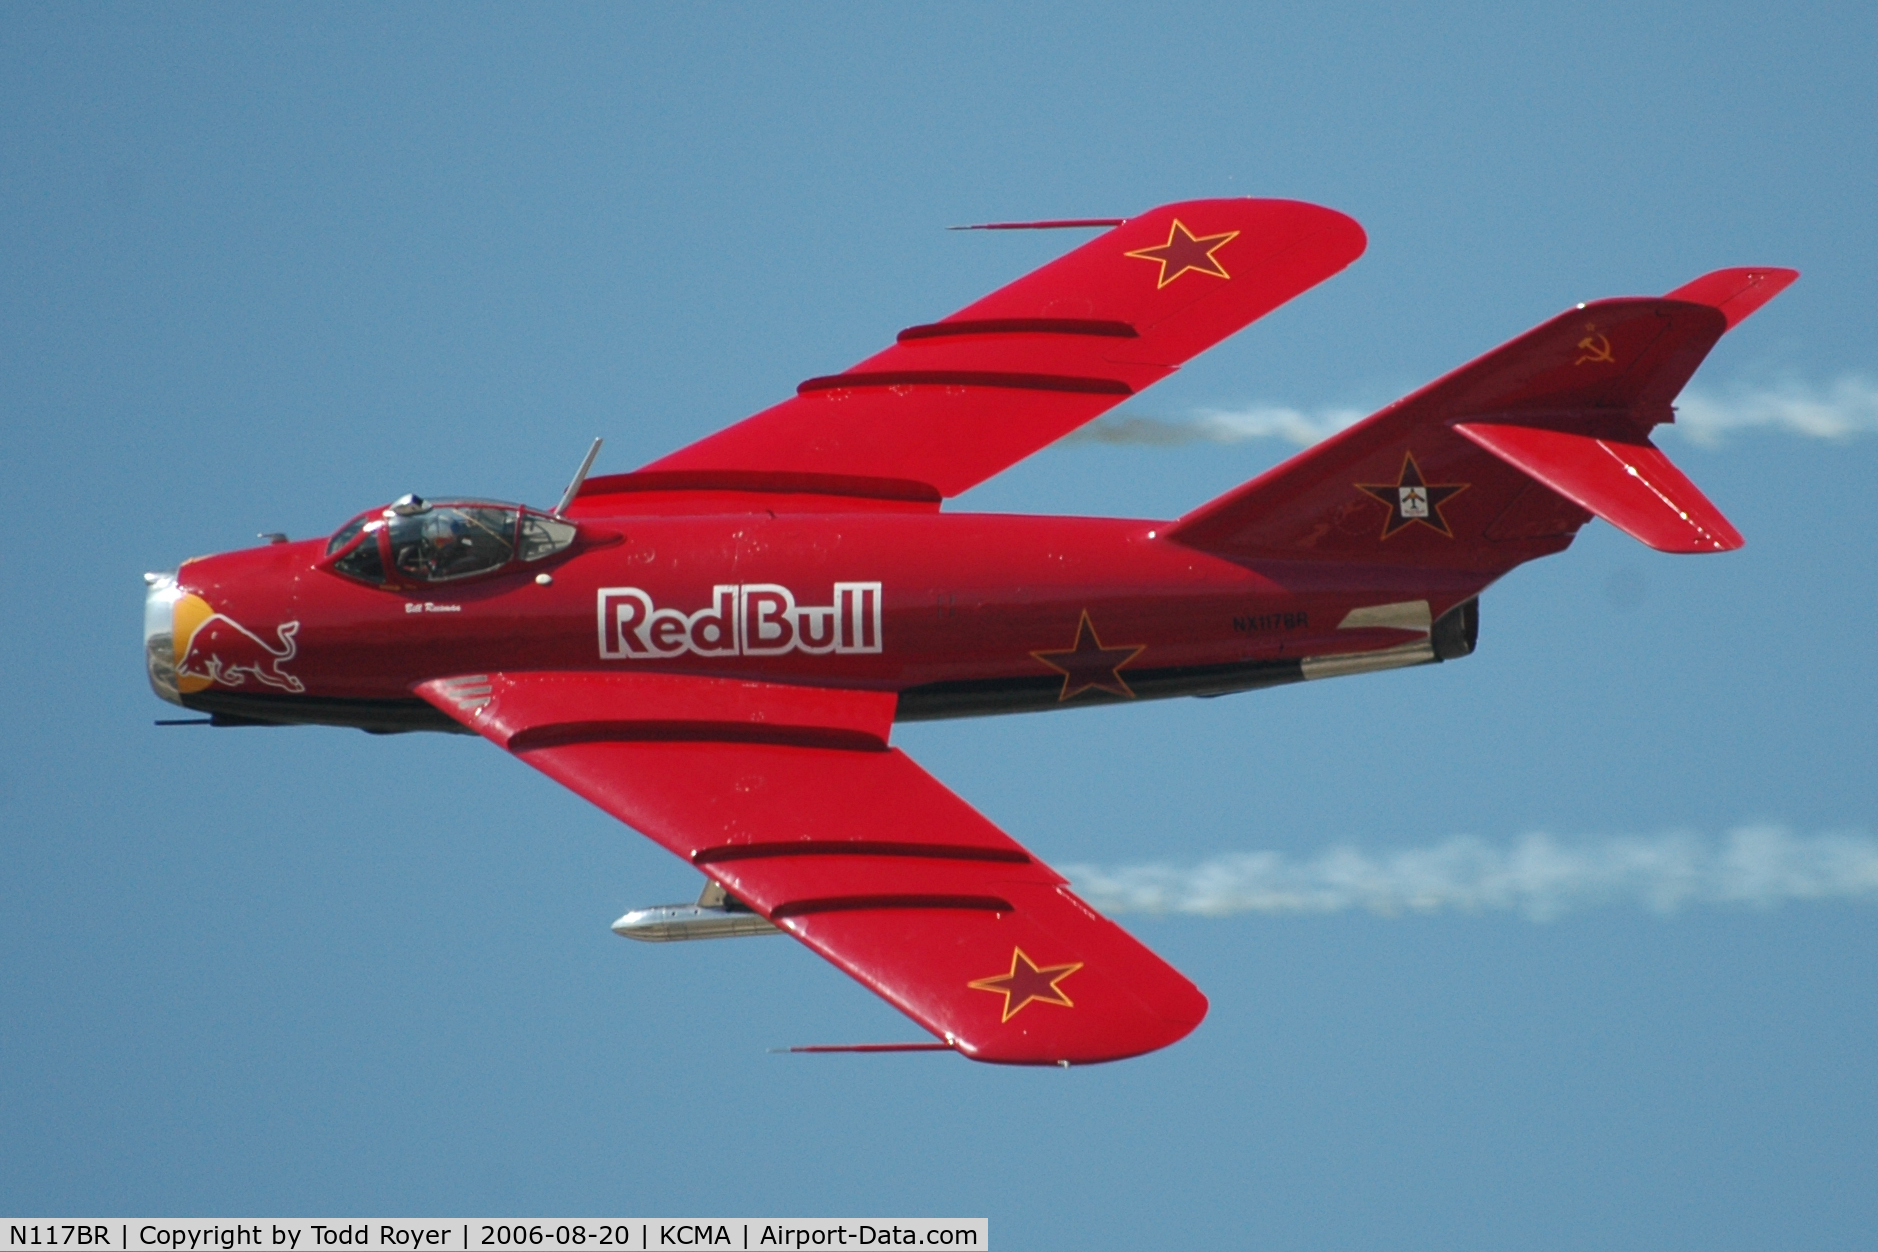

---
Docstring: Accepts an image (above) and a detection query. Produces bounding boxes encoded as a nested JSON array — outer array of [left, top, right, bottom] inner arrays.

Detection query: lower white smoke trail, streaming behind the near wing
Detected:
[[1063, 826, 1878, 922]]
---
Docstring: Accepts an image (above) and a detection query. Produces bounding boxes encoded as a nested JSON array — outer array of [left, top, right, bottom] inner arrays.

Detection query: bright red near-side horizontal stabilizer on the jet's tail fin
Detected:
[[1454, 422, 1743, 552]]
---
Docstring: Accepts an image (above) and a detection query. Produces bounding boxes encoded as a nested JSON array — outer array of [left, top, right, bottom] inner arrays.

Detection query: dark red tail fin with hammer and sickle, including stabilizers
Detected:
[[1168, 268, 1799, 571]]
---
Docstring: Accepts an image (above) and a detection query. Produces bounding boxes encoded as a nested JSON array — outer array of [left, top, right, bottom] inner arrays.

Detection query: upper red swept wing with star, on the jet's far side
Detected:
[[575, 199, 1365, 514]]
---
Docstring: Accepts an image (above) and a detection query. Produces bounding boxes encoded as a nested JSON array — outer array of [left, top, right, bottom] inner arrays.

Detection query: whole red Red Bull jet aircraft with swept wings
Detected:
[[145, 199, 1797, 1064]]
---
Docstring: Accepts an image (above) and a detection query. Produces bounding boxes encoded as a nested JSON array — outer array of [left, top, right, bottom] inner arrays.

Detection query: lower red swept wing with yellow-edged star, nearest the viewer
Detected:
[[417, 674, 1206, 1064]]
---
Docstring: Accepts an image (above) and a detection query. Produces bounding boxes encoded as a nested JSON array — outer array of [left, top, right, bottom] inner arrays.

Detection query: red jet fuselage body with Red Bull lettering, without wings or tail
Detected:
[[152, 511, 1493, 730]]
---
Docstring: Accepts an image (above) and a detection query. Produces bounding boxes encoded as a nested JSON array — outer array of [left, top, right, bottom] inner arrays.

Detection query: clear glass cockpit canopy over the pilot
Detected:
[[327, 496, 577, 586]]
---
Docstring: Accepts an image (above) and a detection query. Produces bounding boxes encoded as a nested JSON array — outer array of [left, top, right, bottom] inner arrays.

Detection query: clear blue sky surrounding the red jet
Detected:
[[0, 4, 1878, 1248]]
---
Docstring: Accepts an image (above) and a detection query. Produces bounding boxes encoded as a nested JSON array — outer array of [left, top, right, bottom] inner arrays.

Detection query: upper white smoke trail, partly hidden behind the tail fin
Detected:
[[1063, 375, 1878, 449]]
